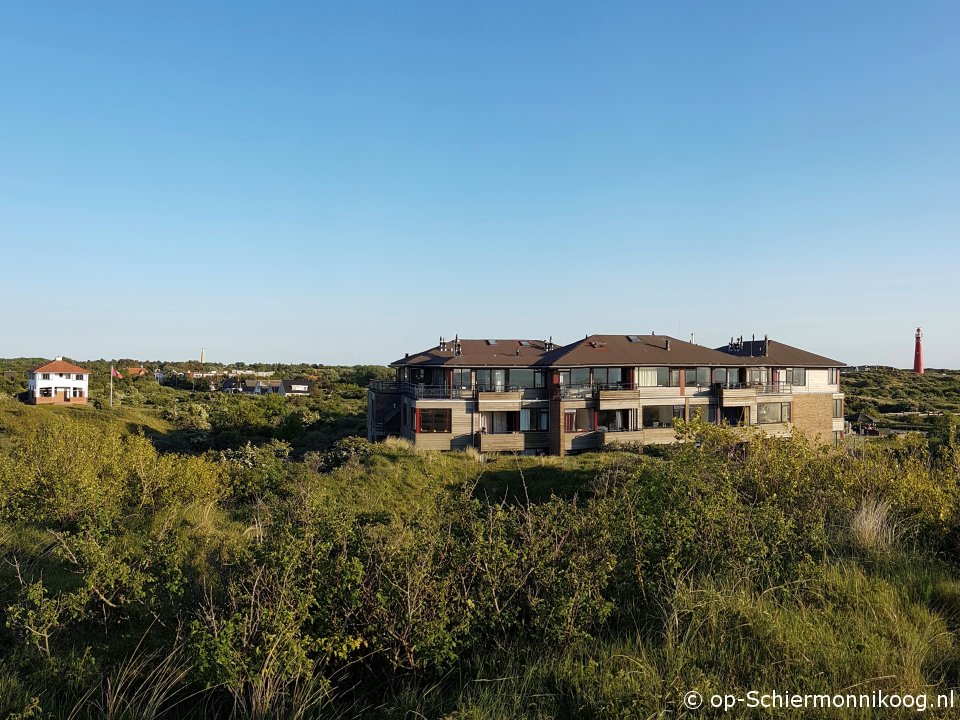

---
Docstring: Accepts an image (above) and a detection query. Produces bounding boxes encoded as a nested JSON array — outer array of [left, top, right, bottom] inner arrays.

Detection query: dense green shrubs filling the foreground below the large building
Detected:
[[0, 414, 960, 717]]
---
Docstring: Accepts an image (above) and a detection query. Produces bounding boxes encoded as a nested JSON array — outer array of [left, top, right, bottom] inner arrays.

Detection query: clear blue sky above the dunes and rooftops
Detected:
[[0, 0, 960, 367]]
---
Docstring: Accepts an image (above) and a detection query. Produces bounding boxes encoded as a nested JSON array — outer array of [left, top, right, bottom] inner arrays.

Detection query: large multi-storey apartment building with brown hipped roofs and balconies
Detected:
[[367, 335, 844, 455]]
